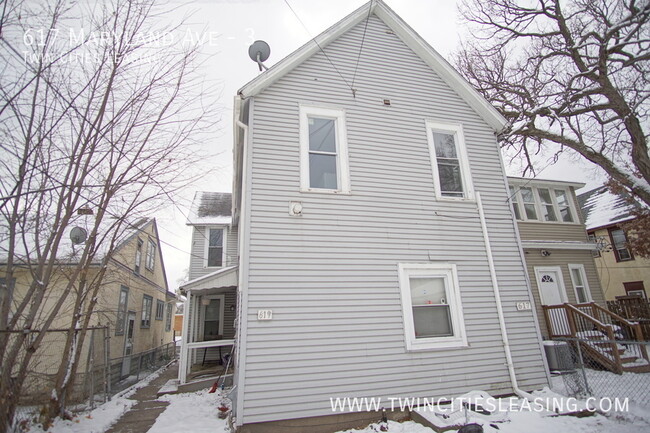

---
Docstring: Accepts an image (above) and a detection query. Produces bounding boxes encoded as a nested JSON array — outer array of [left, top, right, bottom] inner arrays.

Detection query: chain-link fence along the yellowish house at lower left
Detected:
[[6, 327, 176, 432]]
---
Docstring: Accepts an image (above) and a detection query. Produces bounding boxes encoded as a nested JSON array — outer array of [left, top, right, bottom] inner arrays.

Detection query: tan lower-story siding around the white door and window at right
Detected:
[[524, 249, 606, 338]]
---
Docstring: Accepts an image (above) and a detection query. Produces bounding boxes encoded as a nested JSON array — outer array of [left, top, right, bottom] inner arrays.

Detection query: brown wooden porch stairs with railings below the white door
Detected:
[[542, 302, 650, 374]]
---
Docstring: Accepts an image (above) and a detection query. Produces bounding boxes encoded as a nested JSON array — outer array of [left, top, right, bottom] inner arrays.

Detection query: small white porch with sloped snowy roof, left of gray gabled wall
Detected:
[[178, 266, 237, 385]]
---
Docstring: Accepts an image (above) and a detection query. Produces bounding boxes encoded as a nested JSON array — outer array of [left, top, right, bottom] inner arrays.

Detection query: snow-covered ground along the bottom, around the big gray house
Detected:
[[24, 370, 650, 433]]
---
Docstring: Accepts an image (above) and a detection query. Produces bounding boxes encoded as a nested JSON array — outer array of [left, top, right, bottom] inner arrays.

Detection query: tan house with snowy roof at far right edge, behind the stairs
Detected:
[[578, 186, 650, 300]]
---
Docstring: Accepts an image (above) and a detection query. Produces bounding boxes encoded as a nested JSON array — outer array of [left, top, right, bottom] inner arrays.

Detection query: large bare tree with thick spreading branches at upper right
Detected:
[[455, 0, 650, 205]]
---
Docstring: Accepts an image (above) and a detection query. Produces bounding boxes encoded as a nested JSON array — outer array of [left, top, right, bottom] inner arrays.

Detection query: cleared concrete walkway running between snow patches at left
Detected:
[[106, 362, 178, 433]]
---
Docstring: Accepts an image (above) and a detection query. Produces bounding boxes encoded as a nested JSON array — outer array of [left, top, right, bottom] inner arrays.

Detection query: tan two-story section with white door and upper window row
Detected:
[[508, 177, 605, 338]]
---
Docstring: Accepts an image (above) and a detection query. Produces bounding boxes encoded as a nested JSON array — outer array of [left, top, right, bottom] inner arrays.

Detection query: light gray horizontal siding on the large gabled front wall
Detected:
[[238, 16, 547, 423]]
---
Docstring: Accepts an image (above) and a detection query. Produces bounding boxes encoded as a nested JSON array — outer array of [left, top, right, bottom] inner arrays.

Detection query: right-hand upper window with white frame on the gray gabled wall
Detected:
[[426, 121, 473, 199]]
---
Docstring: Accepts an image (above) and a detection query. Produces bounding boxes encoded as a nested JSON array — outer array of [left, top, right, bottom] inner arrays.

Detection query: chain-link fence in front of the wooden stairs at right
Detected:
[[547, 338, 650, 407]]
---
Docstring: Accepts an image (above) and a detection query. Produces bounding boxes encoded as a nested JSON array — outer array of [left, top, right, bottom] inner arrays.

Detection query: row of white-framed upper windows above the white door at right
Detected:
[[510, 186, 576, 223]]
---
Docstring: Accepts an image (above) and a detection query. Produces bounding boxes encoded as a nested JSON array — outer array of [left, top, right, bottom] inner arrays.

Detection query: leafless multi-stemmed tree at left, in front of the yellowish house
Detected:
[[0, 0, 212, 426]]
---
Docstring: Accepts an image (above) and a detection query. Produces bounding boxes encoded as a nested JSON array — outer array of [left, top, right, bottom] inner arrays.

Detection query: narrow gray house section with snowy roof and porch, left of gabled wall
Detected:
[[179, 191, 238, 372]]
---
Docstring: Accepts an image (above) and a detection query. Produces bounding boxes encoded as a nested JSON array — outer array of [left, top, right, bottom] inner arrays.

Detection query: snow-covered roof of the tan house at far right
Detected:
[[578, 186, 634, 230]]
